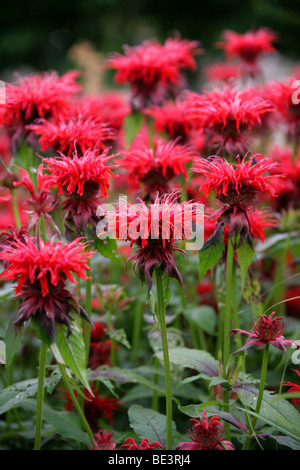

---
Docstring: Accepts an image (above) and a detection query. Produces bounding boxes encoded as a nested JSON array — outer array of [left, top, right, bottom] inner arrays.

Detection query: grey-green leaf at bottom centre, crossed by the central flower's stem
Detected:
[[128, 405, 176, 447]]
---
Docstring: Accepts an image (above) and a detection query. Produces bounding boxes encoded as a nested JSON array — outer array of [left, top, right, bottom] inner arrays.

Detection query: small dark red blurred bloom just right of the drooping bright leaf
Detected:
[[89, 322, 111, 370]]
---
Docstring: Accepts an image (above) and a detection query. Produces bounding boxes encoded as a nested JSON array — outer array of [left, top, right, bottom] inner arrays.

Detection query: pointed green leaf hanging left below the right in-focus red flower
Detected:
[[199, 225, 225, 282]]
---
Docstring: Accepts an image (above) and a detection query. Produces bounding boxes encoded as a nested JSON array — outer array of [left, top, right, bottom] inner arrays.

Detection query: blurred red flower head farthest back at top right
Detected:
[[218, 28, 277, 76]]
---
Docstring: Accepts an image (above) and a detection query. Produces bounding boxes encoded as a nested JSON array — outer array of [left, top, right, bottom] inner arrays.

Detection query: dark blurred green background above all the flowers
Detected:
[[0, 0, 300, 78]]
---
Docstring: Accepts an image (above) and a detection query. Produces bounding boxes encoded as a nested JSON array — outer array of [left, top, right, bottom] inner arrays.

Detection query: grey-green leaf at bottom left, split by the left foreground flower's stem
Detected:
[[20, 399, 91, 447]]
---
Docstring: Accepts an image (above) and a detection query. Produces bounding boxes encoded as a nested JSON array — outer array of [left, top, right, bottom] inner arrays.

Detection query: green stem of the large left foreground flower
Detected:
[[34, 341, 48, 450]]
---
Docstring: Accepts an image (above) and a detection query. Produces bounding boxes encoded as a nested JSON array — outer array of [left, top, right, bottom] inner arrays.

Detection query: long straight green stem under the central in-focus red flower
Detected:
[[156, 268, 172, 450]]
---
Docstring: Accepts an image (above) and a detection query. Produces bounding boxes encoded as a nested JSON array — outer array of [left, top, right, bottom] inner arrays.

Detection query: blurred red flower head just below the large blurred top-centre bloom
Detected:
[[145, 92, 194, 144]]
